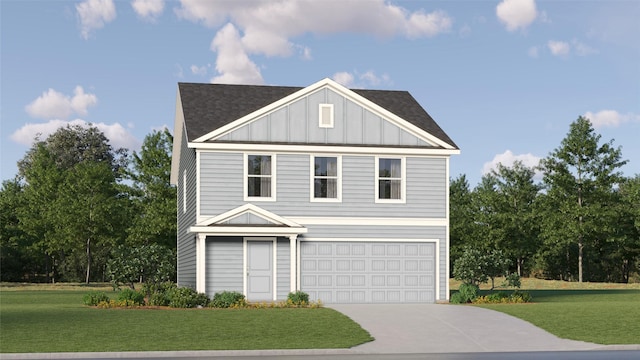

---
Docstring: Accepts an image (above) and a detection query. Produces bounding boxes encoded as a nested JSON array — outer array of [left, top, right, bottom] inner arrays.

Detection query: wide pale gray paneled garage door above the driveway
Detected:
[[300, 241, 436, 304]]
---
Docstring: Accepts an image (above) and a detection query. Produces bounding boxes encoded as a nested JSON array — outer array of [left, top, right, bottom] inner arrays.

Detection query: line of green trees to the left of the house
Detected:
[[0, 126, 176, 283]]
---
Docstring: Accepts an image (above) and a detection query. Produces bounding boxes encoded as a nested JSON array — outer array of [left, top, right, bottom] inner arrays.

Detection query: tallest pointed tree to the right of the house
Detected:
[[540, 116, 626, 282]]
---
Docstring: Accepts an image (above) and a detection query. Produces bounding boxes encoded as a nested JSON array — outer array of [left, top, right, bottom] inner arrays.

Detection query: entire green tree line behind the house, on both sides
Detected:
[[0, 117, 640, 284]]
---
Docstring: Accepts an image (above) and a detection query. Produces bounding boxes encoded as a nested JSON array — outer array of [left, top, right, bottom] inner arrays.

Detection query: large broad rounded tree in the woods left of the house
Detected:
[[17, 126, 128, 282]]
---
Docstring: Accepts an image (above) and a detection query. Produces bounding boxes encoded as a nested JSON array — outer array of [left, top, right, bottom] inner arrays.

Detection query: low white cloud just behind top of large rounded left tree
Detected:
[[11, 119, 141, 149]]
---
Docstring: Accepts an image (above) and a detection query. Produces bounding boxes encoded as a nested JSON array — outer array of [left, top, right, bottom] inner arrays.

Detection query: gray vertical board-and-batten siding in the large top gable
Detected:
[[220, 88, 433, 146]]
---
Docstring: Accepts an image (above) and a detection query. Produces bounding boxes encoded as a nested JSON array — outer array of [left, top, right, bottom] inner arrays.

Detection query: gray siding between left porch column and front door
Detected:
[[205, 237, 244, 298]]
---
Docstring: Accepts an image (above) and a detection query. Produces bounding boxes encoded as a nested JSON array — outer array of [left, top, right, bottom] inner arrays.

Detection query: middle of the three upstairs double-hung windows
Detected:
[[311, 156, 342, 201]]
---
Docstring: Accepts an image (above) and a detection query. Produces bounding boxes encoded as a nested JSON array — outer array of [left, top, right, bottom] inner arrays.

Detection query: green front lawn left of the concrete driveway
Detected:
[[0, 287, 373, 353]]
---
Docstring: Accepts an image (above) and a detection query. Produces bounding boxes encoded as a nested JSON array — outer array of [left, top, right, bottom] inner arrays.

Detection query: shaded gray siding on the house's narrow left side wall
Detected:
[[176, 127, 196, 289]]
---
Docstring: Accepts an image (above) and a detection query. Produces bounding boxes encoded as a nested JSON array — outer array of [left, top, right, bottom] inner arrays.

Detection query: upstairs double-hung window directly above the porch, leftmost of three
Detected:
[[245, 154, 275, 200]]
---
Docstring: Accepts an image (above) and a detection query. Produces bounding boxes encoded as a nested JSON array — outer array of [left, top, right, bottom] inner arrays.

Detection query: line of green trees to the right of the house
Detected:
[[450, 117, 640, 282]]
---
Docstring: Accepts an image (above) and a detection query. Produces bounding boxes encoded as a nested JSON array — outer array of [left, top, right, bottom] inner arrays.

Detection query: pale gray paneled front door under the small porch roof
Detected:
[[247, 241, 273, 301]]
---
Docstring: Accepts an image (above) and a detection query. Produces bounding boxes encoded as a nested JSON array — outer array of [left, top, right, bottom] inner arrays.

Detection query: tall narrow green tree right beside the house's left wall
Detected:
[[128, 128, 177, 249]]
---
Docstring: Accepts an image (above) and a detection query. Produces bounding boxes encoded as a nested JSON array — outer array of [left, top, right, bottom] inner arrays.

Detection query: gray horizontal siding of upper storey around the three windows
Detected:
[[200, 151, 448, 218]]
